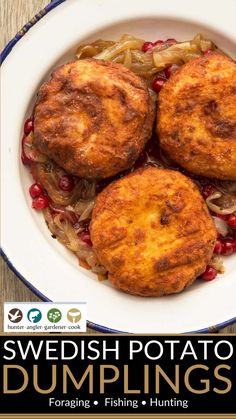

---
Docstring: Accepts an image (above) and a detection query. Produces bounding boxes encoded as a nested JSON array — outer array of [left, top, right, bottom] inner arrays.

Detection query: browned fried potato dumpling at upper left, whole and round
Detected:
[[34, 59, 154, 179]]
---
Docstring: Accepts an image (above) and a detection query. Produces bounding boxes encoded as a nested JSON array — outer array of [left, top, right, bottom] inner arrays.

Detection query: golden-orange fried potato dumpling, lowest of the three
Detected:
[[90, 167, 216, 296]]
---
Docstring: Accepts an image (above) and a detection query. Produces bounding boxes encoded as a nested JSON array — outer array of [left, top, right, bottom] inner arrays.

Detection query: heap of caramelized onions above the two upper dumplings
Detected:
[[76, 34, 218, 82]]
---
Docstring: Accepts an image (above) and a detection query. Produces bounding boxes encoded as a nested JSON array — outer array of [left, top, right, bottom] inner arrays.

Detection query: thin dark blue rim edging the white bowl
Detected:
[[0, 0, 236, 334]]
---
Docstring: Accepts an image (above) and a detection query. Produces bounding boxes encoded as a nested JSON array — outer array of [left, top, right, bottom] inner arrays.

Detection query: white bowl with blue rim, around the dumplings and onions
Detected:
[[1, 0, 236, 333]]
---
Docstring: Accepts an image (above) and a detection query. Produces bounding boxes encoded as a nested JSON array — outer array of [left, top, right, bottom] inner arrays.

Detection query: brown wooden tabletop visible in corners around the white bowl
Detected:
[[0, 0, 236, 333]]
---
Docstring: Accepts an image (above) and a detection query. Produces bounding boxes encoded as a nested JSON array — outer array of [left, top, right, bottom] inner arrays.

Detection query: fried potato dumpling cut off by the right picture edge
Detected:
[[157, 53, 236, 180]]
